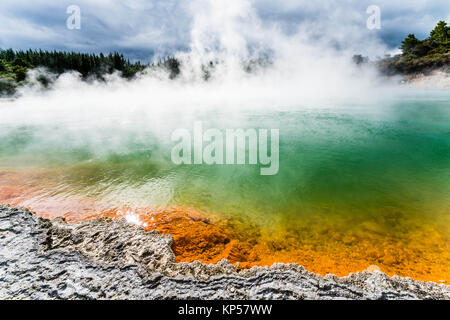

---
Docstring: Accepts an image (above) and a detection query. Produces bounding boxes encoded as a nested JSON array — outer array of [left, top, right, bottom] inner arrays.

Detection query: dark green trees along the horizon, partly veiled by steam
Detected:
[[0, 21, 450, 96]]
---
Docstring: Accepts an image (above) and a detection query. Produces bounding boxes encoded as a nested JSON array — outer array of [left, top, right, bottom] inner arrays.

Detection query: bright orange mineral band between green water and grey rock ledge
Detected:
[[0, 171, 450, 283]]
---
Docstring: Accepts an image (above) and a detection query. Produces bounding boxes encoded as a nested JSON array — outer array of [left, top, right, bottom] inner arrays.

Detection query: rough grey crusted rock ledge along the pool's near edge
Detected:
[[0, 206, 450, 299]]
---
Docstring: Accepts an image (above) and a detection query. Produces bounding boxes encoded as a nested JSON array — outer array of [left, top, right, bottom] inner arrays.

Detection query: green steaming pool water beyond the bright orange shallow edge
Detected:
[[0, 91, 450, 280]]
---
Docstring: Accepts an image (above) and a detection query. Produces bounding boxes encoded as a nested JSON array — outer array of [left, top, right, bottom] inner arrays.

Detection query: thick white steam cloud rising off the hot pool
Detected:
[[0, 0, 426, 160]]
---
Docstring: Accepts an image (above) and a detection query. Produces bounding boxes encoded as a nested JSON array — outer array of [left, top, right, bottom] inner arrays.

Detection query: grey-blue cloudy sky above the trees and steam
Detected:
[[0, 0, 450, 59]]
